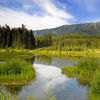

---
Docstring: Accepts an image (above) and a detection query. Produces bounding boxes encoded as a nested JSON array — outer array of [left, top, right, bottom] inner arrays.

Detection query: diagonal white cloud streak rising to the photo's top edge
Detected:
[[33, 0, 73, 19]]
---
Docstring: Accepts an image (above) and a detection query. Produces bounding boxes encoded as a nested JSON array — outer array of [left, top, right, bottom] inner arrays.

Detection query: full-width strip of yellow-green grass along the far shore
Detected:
[[0, 47, 100, 57]]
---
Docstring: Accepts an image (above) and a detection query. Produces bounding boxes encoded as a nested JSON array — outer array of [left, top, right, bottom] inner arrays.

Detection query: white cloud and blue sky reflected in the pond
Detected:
[[20, 64, 88, 100]]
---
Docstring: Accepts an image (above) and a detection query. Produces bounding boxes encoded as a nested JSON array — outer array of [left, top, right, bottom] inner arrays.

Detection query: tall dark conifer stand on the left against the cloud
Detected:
[[0, 24, 35, 49]]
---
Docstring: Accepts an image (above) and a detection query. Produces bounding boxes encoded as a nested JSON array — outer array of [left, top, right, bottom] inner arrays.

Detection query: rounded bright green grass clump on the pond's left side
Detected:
[[0, 59, 36, 81]]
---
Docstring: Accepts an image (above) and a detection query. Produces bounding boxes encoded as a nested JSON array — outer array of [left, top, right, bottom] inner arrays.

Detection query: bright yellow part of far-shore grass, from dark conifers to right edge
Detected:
[[29, 48, 100, 57]]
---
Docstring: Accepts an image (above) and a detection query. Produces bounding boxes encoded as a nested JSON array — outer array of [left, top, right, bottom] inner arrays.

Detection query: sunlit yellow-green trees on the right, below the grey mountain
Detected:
[[52, 34, 100, 51]]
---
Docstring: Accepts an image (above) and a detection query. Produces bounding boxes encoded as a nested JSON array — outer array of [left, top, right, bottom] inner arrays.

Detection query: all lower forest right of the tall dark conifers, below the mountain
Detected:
[[36, 34, 100, 51]]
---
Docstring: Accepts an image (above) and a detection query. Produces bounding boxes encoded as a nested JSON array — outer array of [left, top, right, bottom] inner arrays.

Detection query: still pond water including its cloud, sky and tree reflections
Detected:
[[0, 56, 88, 100]]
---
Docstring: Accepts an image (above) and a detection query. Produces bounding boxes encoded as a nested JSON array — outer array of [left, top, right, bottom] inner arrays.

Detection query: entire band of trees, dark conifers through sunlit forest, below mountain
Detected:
[[0, 24, 100, 51]]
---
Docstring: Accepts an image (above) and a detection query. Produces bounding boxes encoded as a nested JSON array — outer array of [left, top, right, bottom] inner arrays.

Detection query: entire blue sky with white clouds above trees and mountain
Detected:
[[0, 0, 100, 30]]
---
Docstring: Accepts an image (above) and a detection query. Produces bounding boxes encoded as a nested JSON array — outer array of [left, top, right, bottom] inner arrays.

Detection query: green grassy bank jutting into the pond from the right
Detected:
[[62, 59, 100, 100]]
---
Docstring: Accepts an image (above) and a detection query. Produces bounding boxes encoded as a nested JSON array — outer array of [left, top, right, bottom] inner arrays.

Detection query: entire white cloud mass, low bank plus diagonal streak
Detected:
[[0, 0, 74, 30]]
